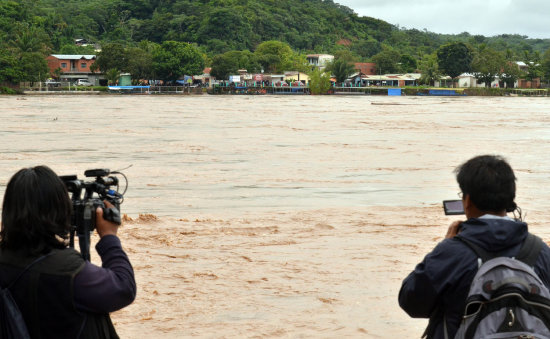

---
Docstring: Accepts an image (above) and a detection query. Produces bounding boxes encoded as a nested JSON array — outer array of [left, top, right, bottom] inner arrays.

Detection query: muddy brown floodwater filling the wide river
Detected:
[[0, 95, 550, 338]]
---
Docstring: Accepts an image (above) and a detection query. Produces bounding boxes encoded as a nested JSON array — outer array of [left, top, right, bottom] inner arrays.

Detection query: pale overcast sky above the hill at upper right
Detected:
[[334, 0, 550, 39]]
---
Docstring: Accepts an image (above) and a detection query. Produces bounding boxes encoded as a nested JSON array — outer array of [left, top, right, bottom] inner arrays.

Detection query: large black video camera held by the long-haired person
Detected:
[[60, 169, 128, 261]]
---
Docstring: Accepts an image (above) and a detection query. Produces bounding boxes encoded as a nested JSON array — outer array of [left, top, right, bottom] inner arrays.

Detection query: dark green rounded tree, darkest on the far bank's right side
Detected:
[[437, 42, 473, 86]]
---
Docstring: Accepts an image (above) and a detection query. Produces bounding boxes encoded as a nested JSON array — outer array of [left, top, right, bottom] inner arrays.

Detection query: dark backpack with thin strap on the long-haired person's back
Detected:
[[0, 255, 46, 339]]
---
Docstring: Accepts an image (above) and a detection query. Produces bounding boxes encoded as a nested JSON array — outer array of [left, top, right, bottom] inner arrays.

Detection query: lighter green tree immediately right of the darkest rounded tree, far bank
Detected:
[[472, 45, 506, 87]]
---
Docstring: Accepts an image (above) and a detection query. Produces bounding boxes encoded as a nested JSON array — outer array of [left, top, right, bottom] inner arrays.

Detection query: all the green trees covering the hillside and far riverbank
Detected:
[[0, 0, 550, 87]]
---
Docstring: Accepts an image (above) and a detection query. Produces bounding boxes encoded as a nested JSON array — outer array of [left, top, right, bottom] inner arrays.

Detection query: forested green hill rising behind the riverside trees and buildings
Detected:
[[0, 0, 550, 60]]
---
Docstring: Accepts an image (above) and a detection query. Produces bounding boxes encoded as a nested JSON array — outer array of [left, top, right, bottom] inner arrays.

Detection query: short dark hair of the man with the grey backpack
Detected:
[[455, 155, 517, 212]]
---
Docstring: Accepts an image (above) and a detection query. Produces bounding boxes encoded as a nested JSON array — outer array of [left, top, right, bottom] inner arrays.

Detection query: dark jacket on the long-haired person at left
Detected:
[[0, 236, 136, 339]]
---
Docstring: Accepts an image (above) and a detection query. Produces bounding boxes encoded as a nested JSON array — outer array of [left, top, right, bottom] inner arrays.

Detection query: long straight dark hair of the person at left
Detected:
[[0, 166, 72, 254]]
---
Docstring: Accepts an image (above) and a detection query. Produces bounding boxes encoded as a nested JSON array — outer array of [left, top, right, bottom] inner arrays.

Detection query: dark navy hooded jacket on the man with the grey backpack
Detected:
[[399, 217, 550, 338]]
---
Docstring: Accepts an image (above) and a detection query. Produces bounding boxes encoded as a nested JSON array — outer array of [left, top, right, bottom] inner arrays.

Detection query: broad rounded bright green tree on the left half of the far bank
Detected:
[[153, 41, 204, 81]]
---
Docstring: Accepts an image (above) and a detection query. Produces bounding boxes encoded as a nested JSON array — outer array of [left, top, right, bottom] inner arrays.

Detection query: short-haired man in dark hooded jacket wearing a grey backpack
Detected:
[[399, 155, 550, 338]]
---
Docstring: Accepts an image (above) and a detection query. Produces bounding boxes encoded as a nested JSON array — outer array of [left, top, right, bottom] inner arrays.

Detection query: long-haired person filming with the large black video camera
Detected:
[[0, 166, 136, 338]]
